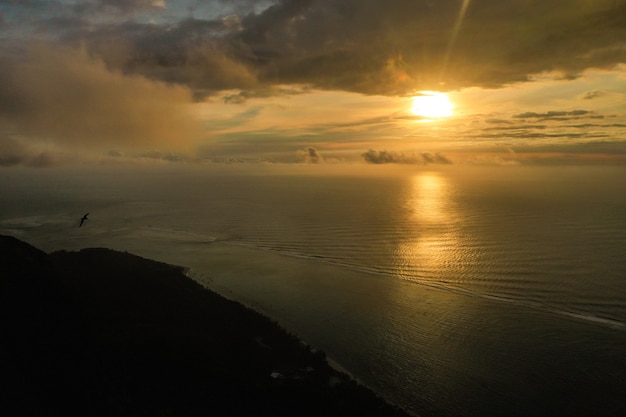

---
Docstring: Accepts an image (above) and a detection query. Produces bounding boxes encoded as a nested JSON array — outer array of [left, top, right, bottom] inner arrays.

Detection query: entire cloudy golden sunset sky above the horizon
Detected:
[[0, 0, 626, 167]]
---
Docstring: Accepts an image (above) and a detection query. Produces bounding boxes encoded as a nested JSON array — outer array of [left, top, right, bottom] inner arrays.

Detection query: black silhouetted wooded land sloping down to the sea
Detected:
[[0, 236, 407, 417]]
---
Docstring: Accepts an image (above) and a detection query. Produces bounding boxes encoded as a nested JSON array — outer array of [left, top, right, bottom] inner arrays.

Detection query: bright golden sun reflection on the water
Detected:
[[397, 172, 459, 281]]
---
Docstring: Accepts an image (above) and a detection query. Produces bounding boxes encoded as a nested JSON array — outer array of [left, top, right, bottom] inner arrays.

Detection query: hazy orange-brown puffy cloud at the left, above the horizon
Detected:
[[0, 44, 200, 155]]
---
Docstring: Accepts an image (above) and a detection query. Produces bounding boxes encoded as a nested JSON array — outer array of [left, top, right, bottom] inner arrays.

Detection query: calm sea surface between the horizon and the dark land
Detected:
[[0, 166, 626, 416]]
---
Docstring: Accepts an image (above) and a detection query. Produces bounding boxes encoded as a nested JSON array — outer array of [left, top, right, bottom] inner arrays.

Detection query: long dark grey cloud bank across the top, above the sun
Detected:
[[3, 0, 626, 97]]
